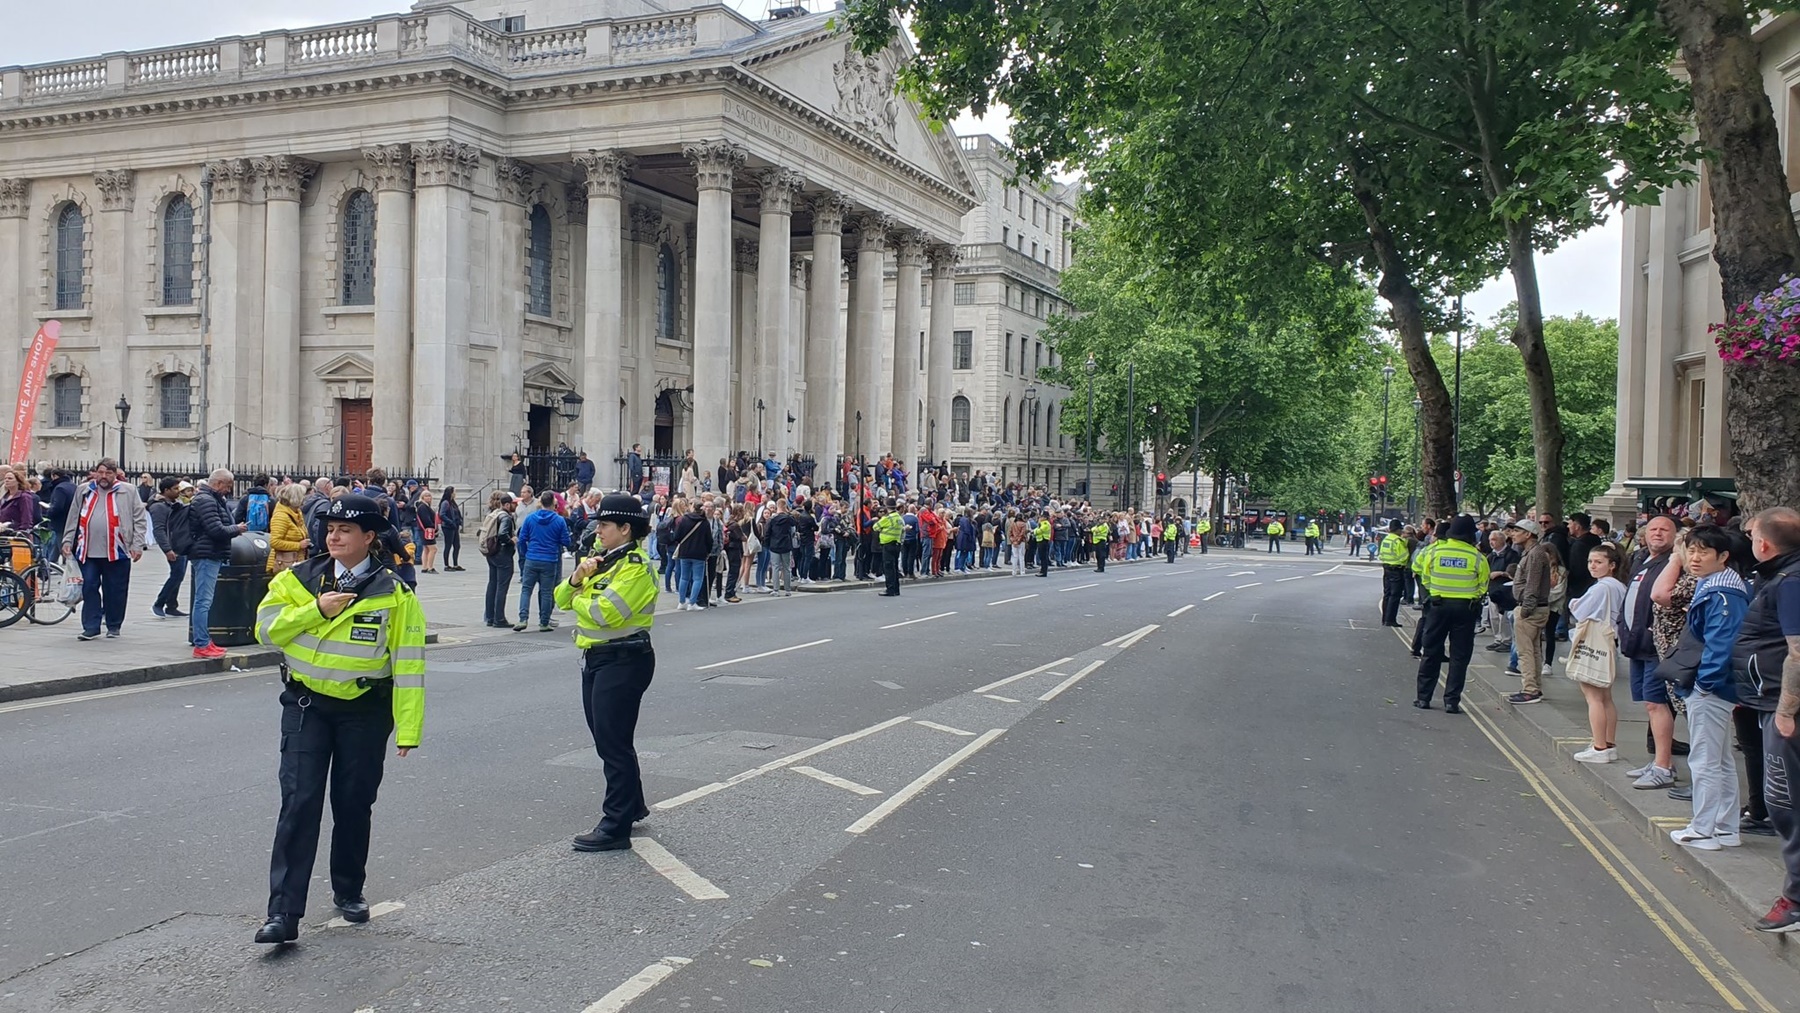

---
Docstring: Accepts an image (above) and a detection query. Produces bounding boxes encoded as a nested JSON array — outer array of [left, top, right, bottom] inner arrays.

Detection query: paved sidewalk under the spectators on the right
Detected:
[[1400, 606, 1800, 966]]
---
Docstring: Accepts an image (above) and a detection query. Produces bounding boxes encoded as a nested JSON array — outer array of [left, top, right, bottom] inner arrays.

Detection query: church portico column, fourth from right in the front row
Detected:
[[803, 193, 850, 467]]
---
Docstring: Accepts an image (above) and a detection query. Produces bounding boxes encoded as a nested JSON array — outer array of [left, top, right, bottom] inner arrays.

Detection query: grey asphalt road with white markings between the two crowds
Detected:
[[0, 554, 1800, 1013]]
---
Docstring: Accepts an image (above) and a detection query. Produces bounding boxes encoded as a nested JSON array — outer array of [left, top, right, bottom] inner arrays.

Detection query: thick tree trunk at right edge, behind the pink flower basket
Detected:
[[1656, 0, 1800, 511]]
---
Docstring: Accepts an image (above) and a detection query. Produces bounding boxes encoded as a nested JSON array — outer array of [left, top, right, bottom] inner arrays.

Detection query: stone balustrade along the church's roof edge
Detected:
[[0, 7, 760, 110]]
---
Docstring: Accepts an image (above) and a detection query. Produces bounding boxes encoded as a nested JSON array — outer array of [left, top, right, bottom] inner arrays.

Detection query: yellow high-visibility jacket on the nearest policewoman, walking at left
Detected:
[[256, 556, 425, 749]]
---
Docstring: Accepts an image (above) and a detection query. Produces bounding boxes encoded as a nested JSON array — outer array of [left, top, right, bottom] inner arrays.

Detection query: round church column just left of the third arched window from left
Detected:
[[252, 155, 315, 466]]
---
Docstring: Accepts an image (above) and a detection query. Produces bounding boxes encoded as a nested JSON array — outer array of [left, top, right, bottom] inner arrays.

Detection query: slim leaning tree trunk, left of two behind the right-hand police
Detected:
[[1352, 184, 1456, 516]]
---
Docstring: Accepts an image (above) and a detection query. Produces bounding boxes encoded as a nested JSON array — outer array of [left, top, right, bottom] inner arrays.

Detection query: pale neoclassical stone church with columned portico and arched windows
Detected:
[[0, 0, 981, 486]]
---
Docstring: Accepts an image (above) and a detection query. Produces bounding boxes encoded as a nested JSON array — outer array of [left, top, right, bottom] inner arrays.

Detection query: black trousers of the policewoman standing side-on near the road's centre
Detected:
[[581, 637, 657, 837]]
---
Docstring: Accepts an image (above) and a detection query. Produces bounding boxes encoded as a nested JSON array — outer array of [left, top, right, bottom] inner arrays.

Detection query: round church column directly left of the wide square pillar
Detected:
[[361, 144, 423, 473]]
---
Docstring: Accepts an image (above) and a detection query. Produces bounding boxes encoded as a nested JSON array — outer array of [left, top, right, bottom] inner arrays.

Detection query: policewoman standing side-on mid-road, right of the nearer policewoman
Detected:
[[556, 493, 657, 851]]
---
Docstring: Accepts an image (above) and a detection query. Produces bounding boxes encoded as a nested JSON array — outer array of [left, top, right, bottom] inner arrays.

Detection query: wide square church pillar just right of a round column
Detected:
[[412, 140, 490, 486]]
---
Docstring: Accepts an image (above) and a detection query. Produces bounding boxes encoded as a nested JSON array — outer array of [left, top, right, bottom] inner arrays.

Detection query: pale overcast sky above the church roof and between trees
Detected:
[[0, 0, 1622, 320]]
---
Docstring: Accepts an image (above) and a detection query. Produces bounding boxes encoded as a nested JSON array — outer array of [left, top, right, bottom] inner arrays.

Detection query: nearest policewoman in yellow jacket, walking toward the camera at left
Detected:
[[256, 495, 425, 943]]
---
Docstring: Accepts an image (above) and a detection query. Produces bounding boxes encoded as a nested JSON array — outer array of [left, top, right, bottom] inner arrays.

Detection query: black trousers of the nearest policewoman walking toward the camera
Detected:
[[268, 684, 394, 918]]
